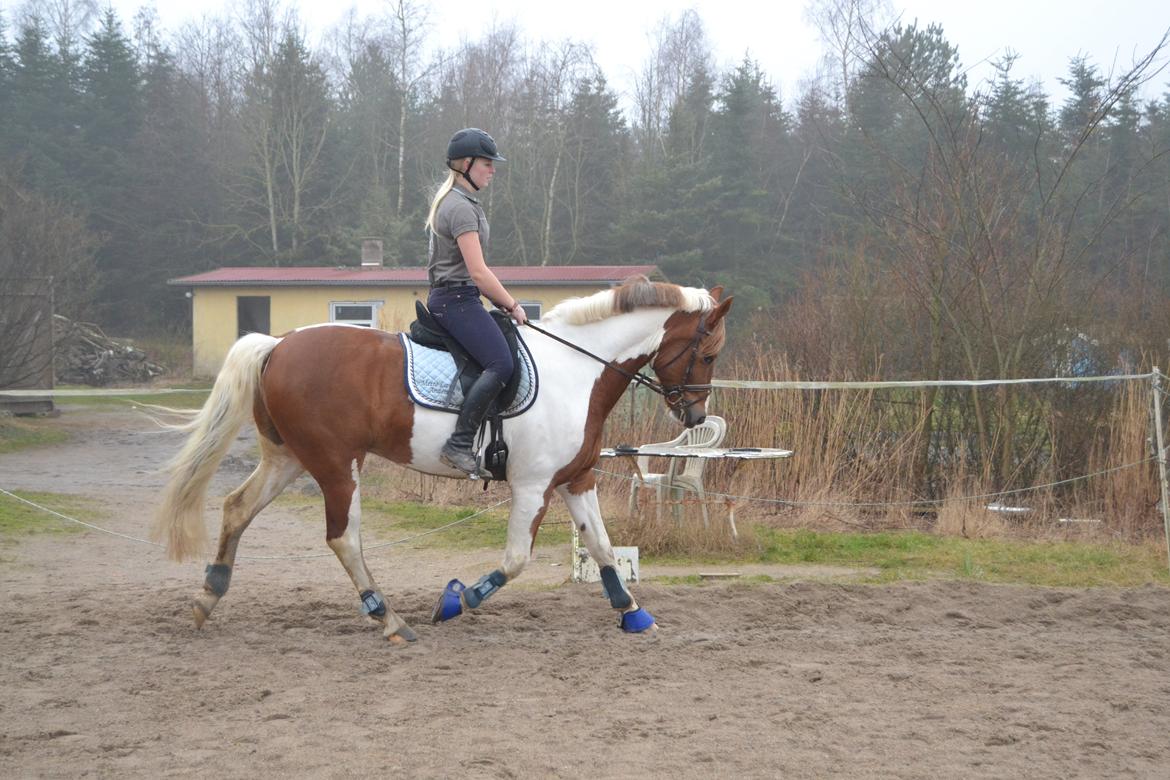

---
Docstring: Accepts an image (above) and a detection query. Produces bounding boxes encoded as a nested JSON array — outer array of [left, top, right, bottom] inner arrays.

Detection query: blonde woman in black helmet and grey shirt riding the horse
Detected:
[[427, 127, 528, 478]]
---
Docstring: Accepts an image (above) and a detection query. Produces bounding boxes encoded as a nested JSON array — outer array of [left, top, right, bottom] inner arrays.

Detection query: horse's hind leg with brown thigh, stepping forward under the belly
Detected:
[[314, 458, 418, 644]]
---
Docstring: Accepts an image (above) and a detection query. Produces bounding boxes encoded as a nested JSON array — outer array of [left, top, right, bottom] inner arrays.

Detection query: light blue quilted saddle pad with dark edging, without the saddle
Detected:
[[398, 333, 537, 417]]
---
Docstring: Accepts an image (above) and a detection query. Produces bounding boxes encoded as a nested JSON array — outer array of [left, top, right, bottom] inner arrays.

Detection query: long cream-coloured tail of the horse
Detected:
[[151, 333, 280, 560]]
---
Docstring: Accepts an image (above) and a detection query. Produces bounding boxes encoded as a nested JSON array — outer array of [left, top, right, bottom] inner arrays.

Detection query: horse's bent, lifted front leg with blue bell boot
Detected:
[[431, 485, 549, 623]]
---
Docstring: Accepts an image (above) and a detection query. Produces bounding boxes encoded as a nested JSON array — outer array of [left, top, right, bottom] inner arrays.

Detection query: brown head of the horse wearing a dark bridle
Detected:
[[651, 287, 731, 428]]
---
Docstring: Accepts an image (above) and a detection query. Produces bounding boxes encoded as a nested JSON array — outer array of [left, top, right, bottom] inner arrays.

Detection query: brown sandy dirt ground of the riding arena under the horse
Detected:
[[0, 413, 1170, 778]]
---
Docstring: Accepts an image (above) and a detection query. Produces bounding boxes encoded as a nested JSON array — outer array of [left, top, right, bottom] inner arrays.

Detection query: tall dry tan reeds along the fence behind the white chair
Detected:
[[334, 336, 1163, 555]]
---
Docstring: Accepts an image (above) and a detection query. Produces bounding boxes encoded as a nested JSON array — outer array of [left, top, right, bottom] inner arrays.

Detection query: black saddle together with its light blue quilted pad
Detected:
[[400, 301, 537, 417]]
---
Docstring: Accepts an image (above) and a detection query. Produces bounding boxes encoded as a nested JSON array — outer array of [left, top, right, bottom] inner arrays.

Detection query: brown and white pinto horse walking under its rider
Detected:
[[152, 276, 732, 644]]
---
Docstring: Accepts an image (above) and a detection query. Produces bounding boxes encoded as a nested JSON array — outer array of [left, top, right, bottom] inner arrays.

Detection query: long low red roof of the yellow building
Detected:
[[167, 265, 662, 287]]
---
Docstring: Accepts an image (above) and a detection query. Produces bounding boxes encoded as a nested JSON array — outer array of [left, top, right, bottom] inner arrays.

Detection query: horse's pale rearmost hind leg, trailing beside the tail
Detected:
[[192, 436, 304, 628]]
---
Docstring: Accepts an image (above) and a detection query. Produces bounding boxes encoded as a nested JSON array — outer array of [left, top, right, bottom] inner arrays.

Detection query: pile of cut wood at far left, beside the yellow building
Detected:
[[53, 315, 166, 387]]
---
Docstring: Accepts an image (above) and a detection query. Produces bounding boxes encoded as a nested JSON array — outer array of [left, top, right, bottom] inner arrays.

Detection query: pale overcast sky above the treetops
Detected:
[[0, 0, 1170, 107]]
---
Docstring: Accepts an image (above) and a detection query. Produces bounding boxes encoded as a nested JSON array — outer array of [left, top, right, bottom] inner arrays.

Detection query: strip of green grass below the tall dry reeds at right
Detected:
[[756, 527, 1170, 587]]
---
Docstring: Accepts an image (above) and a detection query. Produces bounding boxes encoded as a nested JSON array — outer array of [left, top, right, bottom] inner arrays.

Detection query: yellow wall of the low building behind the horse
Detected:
[[192, 284, 605, 377]]
